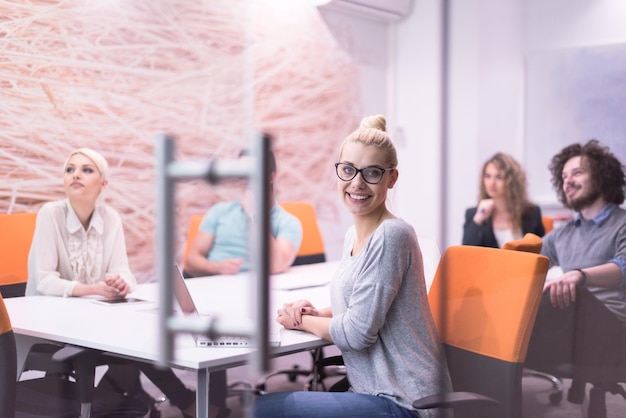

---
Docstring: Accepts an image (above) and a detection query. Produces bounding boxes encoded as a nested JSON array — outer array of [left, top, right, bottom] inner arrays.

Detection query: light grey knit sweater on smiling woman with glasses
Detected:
[[330, 219, 451, 417]]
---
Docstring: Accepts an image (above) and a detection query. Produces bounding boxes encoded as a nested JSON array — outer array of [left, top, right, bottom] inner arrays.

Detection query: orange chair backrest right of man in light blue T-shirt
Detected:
[[280, 202, 326, 266]]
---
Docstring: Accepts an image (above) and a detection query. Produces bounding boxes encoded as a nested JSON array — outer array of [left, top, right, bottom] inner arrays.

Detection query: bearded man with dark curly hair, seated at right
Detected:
[[525, 140, 626, 403]]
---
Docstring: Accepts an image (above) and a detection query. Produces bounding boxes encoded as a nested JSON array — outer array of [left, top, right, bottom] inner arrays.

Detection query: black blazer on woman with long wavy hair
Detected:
[[463, 206, 546, 248]]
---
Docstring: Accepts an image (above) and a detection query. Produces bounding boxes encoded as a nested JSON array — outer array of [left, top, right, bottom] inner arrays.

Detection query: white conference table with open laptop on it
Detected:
[[5, 262, 337, 417]]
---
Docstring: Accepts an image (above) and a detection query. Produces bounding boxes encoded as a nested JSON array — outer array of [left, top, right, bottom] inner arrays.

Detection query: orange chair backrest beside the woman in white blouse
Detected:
[[0, 212, 37, 298]]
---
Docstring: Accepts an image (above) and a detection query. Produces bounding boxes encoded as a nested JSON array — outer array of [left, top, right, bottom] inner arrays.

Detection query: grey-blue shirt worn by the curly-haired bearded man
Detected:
[[541, 205, 626, 321]]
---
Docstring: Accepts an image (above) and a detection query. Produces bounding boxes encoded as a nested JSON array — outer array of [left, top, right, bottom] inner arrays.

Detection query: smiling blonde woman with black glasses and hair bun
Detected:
[[253, 116, 450, 418]]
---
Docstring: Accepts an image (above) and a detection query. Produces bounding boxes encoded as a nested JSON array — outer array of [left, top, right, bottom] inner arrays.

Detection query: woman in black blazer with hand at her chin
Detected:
[[463, 153, 545, 248]]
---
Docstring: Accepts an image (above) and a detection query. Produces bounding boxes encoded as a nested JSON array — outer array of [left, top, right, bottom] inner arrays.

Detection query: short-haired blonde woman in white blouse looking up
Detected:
[[26, 148, 195, 417]]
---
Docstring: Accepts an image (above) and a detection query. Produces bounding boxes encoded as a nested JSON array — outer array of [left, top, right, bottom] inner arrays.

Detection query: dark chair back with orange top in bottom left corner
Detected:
[[0, 295, 17, 417]]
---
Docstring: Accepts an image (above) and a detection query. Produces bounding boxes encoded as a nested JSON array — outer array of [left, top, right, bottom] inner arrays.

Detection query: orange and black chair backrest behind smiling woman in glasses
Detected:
[[428, 245, 548, 418]]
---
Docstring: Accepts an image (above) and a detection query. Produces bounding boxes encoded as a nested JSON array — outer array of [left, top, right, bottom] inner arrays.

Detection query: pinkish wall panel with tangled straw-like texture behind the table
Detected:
[[0, 0, 361, 280]]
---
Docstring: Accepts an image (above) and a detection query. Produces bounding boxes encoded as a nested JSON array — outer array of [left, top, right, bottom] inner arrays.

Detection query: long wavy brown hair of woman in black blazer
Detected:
[[478, 152, 534, 237]]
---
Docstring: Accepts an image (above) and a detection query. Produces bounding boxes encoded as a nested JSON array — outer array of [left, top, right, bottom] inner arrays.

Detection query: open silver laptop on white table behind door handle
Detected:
[[169, 265, 280, 348]]
